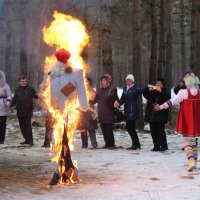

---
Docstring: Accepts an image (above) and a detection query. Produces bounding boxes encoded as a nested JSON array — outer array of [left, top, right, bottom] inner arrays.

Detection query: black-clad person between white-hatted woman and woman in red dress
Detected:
[[143, 78, 170, 151]]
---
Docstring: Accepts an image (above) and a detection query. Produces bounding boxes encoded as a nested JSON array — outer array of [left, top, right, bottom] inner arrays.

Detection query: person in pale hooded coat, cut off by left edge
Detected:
[[0, 71, 12, 144]]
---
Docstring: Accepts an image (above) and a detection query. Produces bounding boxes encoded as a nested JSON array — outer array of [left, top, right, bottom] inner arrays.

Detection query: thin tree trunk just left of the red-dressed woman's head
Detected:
[[180, 0, 186, 74]]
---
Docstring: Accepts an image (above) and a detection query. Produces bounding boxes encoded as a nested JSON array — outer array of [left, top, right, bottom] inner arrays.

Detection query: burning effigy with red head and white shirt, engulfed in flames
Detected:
[[41, 11, 89, 185]]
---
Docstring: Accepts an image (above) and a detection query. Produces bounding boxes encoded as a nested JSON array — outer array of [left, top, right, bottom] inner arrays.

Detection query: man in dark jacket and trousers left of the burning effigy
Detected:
[[11, 75, 38, 146]]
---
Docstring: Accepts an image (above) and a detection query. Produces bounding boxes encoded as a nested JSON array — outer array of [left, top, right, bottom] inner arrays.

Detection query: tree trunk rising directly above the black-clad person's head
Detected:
[[157, 0, 166, 77]]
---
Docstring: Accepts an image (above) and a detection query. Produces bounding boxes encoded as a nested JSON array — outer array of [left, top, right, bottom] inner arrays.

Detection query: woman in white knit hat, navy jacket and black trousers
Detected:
[[114, 74, 143, 150]]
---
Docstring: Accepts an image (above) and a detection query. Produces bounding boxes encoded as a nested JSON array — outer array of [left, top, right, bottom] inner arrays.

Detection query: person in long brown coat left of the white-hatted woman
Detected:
[[90, 75, 118, 149]]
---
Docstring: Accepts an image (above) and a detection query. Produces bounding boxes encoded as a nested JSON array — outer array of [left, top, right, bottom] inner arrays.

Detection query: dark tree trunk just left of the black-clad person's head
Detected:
[[149, 0, 158, 84]]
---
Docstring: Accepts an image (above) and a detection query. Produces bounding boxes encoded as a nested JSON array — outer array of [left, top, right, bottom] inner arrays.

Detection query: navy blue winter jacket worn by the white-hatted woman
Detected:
[[119, 85, 144, 121]]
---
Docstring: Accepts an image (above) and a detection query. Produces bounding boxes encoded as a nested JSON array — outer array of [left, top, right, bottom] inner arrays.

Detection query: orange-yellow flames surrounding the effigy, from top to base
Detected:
[[42, 11, 89, 182]]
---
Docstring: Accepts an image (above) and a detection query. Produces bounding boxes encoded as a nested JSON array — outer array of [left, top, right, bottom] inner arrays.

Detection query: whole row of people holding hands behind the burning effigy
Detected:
[[0, 65, 200, 170]]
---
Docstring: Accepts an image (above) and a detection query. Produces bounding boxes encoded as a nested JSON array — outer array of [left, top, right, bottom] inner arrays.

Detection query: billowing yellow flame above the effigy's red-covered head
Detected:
[[43, 11, 89, 69]]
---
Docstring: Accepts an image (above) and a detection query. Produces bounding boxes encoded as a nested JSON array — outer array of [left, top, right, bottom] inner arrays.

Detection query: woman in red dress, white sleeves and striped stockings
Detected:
[[154, 72, 200, 172]]
